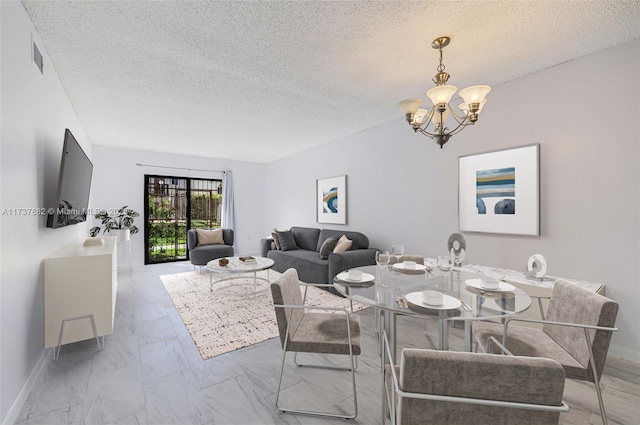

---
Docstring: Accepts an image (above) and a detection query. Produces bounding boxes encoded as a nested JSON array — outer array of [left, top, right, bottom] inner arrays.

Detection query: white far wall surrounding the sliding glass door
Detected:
[[91, 142, 267, 265]]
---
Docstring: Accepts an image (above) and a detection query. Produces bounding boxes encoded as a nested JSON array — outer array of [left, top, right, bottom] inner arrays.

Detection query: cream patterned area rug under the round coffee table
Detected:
[[160, 270, 366, 360]]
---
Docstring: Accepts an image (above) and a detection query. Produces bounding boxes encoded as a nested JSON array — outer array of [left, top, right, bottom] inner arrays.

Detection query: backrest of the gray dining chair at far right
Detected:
[[542, 281, 618, 382]]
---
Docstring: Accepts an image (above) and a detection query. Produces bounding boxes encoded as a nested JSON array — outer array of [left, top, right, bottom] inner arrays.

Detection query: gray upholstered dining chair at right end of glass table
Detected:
[[472, 281, 618, 424]]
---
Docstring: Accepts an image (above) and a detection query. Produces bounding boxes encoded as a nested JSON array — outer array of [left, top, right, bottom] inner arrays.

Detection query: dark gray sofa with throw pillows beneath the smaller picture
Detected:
[[260, 227, 377, 283]]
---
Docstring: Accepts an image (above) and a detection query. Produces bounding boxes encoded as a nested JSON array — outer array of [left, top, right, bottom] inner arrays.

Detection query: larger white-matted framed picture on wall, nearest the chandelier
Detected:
[[458, 144, 540, 236]]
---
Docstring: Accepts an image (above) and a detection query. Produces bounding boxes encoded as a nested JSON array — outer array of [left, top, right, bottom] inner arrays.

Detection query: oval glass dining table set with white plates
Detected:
[[333, 263, 531, 357]]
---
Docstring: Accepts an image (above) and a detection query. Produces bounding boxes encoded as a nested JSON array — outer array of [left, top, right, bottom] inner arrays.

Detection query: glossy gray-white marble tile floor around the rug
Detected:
[[16, 262, 640, 425]]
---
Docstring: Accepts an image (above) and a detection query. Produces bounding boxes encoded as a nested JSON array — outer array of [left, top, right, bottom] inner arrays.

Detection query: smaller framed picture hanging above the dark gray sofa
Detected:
[[316, 175, 347, 224]]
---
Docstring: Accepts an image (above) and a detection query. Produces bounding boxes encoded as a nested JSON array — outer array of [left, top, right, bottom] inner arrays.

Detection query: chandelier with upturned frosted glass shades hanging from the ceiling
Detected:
[[398, 37, 491, 149]]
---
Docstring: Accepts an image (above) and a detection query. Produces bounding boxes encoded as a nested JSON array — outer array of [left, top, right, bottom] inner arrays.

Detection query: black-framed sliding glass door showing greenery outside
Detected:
[[144, 175, 222, 264]]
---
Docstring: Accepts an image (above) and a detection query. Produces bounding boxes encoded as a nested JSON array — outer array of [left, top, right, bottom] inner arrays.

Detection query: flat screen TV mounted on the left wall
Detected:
[[47, 129, 93, 229]]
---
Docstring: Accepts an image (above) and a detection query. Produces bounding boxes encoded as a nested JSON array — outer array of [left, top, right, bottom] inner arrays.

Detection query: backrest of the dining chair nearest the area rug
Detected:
[[271, 269, 304, 348]]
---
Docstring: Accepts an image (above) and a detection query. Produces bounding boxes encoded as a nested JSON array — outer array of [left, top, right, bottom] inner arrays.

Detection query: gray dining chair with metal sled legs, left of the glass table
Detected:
[[271, 269, 361, 419]]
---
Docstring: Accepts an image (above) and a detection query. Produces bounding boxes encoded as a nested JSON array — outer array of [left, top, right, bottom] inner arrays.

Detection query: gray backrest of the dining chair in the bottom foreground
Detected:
[[398, 349, 565, 425]]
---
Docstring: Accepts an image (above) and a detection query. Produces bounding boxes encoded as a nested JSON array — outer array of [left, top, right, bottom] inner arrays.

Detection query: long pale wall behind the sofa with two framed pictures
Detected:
[[265, 40, 640, 361]]
